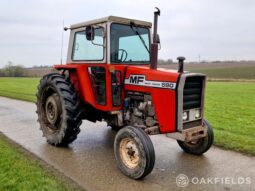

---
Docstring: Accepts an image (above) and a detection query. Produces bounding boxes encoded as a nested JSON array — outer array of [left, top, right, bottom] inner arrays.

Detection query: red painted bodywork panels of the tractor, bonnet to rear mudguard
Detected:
[[55, 63, 179, 133]]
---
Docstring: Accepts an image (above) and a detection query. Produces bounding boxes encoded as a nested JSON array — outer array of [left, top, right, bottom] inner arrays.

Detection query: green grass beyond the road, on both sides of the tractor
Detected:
[[0, 78, 255, 155]]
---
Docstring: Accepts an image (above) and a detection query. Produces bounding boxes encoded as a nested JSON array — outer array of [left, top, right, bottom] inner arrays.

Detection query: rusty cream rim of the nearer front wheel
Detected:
[[120, 138, 140, 169]]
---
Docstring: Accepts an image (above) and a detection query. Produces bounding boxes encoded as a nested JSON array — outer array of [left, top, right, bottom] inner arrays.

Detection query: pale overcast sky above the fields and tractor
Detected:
[[0, 0, 255, 67]]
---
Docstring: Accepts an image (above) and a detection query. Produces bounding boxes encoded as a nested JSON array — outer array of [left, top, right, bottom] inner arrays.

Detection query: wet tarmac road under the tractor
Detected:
[[0, 97, 255, 191]]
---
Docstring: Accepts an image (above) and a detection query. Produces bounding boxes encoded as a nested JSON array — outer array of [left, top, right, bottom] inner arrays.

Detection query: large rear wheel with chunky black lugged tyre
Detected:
[[36, 73, 82, 146]]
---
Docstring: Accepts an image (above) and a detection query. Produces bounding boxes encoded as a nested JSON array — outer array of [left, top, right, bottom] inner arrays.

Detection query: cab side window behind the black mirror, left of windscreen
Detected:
[[72, 28, 104, 61]]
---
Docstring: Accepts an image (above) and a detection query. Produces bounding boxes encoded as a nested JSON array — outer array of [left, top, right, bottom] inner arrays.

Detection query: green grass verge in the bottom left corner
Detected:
[[0, 136, 70, 191]]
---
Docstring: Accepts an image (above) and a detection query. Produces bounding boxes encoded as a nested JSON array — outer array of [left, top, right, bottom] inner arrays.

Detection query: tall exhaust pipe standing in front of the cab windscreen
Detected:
[[150, 7, 160, 70]]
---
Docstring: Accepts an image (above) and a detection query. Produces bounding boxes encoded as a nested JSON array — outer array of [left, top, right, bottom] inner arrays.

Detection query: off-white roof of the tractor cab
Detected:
[[70, 16, 152, 29]]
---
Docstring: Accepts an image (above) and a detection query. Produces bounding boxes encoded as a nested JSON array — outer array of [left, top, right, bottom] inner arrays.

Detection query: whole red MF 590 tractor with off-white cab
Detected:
[[37, 10, 213, 179]]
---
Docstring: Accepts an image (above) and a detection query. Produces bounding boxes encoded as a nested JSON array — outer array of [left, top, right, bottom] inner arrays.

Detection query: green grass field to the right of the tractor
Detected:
[[206, 82, 255, 155]]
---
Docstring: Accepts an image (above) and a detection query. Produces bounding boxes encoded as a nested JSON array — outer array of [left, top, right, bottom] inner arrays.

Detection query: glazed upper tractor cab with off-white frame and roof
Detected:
[[67, 16, 152, 65]]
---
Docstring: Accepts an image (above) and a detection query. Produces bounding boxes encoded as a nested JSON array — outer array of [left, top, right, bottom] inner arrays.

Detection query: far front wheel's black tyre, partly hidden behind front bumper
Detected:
[[177, 120, 214, 155]]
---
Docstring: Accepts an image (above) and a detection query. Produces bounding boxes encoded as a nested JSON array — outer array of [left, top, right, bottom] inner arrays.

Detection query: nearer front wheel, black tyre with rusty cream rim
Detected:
[[114, 126, 155, 179]]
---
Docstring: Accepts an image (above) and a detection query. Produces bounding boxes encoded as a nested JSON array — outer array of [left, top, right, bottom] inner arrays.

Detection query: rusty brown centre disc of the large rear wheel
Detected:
[[45, 95, 60, 125]]
